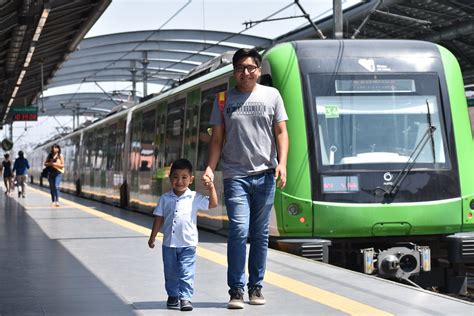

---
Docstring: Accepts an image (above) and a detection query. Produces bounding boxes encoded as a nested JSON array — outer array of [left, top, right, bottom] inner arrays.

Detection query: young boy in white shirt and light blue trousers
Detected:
[[148, 159, 217, 311]]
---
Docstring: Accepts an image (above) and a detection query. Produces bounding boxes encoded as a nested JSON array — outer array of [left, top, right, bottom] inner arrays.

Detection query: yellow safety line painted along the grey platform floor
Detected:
[[28, 188, 393, 316]]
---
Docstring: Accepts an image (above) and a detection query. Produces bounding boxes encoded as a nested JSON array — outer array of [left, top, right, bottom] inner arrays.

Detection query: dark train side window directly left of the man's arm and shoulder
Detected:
[[196, 83, 227, 171]]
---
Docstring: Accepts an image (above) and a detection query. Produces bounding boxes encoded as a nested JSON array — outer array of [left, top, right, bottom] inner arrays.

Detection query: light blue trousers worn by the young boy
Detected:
[[162, 246, 196, 301]]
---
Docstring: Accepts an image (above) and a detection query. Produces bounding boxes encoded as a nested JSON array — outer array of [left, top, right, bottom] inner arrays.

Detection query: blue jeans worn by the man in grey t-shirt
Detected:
[[224, 171, 275, 290]]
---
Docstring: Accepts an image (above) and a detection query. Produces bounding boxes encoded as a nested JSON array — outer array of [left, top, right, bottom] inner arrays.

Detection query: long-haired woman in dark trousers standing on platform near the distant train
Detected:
[[44, 144, 64, 207]]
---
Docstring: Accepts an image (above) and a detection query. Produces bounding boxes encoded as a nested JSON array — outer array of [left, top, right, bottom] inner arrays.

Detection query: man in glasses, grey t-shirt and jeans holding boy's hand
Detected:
[[202, 49, 288, 309]]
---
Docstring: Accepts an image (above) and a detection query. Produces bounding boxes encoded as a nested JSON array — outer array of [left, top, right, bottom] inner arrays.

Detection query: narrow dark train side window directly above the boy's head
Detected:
[[165, 99, 186, 166]]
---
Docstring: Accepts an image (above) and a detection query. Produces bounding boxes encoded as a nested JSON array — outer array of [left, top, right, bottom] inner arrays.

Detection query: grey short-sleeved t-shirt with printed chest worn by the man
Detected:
[[210, 84, 288, 179]]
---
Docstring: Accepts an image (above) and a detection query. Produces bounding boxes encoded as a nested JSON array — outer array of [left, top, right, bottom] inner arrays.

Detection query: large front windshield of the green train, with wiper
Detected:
[[310, 74, 448, 169]]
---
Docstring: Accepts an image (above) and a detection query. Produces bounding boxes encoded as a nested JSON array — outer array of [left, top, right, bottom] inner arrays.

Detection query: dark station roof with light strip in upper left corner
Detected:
[[0, 0, 111, 128]]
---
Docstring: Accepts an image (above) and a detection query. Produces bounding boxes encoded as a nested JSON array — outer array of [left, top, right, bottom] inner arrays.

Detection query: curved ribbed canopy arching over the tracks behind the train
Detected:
[[48, 30, 271, 88]]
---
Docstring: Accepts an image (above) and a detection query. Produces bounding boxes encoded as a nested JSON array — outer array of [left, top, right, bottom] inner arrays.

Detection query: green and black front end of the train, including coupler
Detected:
[[263, 40, 474, 292]]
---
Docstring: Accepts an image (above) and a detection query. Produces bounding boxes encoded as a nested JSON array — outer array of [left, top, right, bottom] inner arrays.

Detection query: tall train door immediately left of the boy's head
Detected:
[[138, 108, 156, 212]]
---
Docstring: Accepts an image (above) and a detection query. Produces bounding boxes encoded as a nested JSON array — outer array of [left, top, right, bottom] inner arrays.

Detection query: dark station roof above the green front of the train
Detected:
[[276, 0, 474, 87]]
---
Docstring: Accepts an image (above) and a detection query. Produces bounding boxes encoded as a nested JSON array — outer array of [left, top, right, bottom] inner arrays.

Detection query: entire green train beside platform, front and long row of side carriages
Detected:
[[30, 40, 474, 293]]
